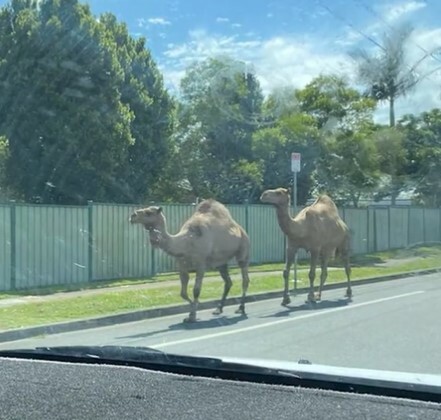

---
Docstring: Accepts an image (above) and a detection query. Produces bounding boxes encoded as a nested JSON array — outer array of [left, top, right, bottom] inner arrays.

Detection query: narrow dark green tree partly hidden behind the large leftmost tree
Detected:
[[100, 13, 175, 202]]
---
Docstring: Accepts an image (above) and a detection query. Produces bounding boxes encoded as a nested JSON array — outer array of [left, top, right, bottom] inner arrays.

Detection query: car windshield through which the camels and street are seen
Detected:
[[0, 0, 441, 375]]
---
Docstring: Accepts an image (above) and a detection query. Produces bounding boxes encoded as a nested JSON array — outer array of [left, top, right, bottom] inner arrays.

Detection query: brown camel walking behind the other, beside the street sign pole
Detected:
[[260, 188, 352, 305]]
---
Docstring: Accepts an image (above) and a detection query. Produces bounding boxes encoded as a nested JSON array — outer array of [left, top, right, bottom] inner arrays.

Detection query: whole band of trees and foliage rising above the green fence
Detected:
[[0, 0, 441, 206]]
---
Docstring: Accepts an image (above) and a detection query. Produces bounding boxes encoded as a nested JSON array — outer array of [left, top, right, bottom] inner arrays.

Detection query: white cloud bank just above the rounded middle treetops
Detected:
[[163, 30, 352, 93]]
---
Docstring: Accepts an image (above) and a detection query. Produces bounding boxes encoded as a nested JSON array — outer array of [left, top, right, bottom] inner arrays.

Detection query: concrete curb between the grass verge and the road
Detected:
[[0, 268, 441, 343]]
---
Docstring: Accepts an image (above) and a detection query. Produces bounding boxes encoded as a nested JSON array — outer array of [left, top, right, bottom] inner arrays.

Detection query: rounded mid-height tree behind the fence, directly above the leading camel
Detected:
[[176, 57, 263, 203]]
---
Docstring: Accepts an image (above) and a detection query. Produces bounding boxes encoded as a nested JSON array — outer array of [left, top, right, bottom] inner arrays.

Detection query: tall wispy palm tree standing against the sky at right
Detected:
[[350, 24, 440, 127]]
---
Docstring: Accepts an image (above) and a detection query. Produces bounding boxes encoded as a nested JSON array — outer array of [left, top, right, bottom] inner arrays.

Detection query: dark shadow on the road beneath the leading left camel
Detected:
[[118, 314, 248, 340]]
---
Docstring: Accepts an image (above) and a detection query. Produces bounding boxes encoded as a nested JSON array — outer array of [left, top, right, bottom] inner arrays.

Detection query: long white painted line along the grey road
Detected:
[[149, 290, 424, 348]]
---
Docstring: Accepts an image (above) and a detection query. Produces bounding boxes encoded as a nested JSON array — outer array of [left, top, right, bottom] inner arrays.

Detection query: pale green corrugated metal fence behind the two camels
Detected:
[[0, 203, 441, 291]]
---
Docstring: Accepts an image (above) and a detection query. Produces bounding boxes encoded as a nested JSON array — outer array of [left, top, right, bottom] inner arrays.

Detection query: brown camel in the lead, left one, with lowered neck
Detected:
[[130, 199, 250, 322]]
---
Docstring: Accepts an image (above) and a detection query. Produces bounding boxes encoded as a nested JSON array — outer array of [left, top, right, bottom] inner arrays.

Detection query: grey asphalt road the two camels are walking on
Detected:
[[0, 274, 441, 374]]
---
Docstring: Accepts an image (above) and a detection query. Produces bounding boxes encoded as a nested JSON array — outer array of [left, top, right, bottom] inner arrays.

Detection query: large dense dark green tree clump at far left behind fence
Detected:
[[0, 0, 171, 204]]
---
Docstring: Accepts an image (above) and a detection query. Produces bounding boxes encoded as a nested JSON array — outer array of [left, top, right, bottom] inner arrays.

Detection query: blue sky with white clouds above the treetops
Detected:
[[0, 0, 441, 120]]
